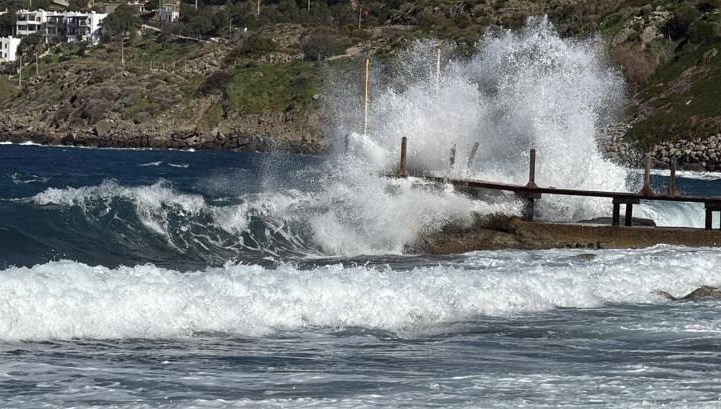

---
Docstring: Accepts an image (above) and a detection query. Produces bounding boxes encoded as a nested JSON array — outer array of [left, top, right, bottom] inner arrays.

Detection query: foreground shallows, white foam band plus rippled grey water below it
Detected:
[[0, 246, 721, 408]]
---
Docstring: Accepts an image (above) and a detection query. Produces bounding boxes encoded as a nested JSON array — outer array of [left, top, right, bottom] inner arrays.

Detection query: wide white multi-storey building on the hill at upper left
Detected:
[[16, 9, 107, 44]]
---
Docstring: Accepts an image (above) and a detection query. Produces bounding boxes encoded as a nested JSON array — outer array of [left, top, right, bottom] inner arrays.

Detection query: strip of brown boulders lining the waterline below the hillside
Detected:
[[5, 114, 721, 172]]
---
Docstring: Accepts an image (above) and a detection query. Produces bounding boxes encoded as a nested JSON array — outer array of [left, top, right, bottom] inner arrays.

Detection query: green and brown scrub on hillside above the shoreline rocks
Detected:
[[0, 0, 721, 147]]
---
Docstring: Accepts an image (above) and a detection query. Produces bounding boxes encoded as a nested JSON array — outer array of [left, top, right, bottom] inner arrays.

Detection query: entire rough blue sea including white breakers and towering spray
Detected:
[[0, 19, 721, 408]]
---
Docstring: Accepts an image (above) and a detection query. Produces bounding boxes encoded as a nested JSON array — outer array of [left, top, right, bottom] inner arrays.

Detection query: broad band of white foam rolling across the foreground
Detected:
[[0, 247, 721, 340]]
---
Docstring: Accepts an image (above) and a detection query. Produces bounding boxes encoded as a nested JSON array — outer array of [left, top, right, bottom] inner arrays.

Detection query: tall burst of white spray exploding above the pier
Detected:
[[326, 18, 628, 220]]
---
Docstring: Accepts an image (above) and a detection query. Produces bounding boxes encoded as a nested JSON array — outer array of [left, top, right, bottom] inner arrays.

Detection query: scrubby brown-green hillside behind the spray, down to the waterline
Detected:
[[0, 0, 721, 168]]
